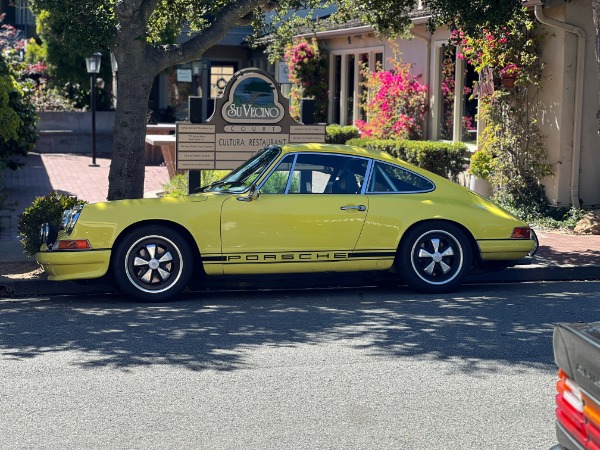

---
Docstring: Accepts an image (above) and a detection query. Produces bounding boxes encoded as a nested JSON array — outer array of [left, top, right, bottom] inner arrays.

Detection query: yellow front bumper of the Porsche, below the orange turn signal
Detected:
[[35, 250, 110, 281]]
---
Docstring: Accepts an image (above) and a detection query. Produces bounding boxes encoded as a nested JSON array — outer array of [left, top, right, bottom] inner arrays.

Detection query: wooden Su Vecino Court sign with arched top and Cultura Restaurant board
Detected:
[[176, 68, 325, 193]]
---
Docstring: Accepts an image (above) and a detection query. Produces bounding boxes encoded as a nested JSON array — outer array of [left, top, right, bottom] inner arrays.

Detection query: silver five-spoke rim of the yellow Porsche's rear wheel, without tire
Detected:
[[411, 230, 464, 285]]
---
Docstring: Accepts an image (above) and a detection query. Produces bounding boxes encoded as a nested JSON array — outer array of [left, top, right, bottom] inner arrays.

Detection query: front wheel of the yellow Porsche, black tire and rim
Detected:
[[113, 225, 194, 302]]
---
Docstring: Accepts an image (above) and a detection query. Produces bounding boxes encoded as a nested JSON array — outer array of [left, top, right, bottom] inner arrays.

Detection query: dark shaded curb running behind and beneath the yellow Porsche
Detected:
[[0, 264, 600, 298]]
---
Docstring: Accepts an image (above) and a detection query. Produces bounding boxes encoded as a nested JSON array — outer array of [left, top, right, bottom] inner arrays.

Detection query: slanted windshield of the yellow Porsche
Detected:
[[200, 147, 281, 192]]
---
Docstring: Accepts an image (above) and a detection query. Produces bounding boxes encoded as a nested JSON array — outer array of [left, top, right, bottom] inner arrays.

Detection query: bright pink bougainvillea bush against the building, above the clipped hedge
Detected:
[[355, 50, 427, 139]]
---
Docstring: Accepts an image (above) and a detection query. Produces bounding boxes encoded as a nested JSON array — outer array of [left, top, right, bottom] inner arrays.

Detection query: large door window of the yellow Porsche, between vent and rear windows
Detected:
[[289, 153, 368, 194]]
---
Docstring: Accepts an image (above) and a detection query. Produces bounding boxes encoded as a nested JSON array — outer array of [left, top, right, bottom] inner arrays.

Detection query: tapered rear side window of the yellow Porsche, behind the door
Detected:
[[368, 162, 435, 193]]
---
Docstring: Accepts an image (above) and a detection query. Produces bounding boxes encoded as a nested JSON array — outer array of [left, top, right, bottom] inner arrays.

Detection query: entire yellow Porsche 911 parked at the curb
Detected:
[[36, 144, 535, 301]]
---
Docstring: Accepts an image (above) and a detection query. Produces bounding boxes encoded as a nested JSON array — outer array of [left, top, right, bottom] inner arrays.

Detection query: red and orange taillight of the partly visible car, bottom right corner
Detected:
[[556, 369, 600, 450]]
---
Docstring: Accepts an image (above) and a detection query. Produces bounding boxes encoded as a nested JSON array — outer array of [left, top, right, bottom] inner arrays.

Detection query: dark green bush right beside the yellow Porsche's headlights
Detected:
[[18, 191, 87, 255]]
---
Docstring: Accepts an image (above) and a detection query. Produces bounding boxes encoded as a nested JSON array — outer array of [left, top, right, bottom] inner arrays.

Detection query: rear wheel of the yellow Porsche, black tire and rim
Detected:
[[398, 222, 473, 293]]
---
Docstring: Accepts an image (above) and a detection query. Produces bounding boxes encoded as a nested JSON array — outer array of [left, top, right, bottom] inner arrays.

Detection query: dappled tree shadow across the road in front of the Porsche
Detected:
[[0, 283, 598, 374]]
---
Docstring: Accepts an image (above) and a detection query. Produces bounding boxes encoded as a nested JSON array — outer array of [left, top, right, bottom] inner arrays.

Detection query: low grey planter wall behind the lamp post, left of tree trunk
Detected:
[[35, 111, 115, 156]]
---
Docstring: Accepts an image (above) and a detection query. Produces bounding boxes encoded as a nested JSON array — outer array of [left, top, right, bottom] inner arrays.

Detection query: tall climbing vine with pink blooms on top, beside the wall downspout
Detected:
[[452, 8, 552, 210]]
